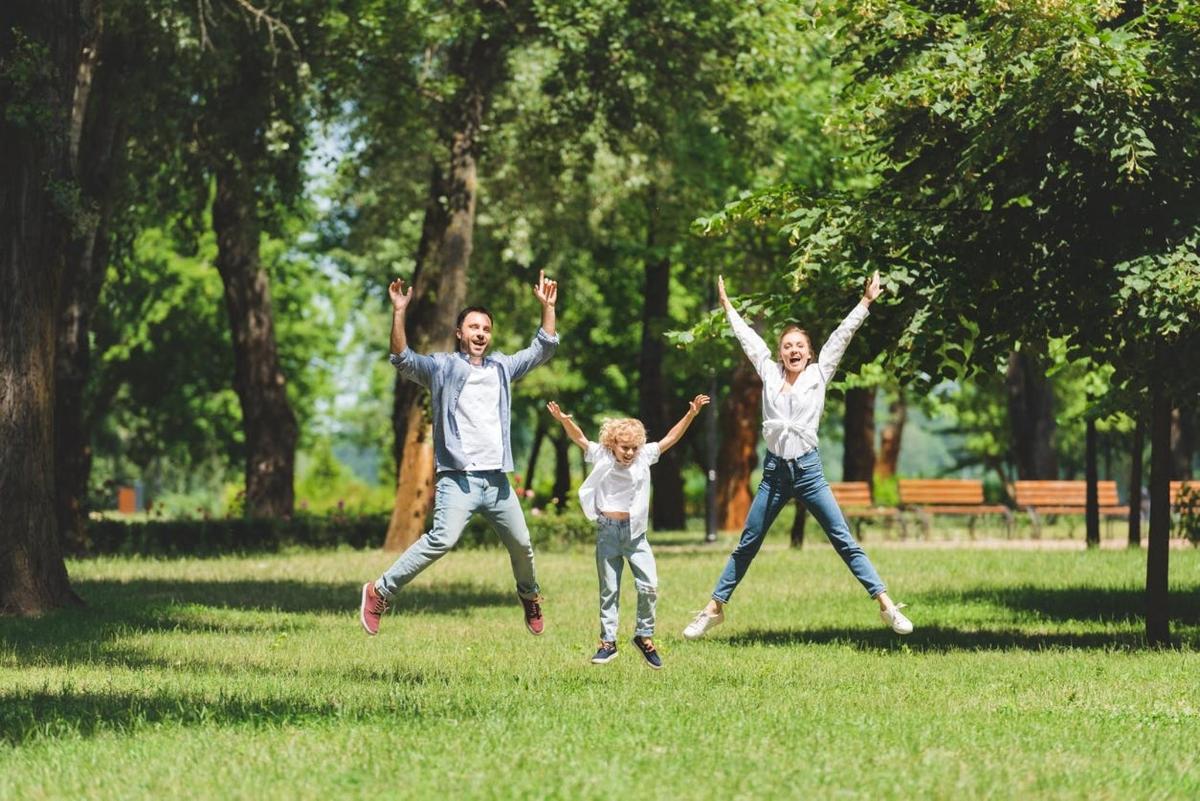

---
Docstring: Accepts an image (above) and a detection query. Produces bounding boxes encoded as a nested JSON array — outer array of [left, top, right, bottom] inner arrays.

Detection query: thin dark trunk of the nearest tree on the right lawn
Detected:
[[1146, 378, 1171, 645]]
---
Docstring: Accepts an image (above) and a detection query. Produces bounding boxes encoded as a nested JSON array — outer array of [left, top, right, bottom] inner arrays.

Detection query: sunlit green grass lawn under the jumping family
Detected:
[[0, 535, 1200, 801]]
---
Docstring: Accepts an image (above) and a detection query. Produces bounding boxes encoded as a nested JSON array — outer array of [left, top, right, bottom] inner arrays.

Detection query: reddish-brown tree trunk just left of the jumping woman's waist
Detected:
[[716, 360, 762, 531]]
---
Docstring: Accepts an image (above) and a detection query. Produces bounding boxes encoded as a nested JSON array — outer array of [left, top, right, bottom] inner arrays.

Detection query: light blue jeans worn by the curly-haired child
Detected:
[[596, 514, 659, 643]]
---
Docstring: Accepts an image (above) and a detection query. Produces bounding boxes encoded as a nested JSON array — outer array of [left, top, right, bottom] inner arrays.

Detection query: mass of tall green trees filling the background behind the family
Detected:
[[0, 0, 1200, 642]]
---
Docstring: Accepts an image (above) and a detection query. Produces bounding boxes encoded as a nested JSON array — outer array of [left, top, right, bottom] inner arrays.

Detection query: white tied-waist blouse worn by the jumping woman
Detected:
[[725, 303, 869, 459]]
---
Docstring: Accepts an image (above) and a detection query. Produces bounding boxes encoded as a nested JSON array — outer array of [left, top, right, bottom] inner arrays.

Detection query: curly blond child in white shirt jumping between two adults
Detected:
[[546, 395, 708, 670]]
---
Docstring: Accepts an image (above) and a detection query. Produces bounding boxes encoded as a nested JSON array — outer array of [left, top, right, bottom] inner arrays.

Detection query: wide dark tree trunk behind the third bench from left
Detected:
[[1006, 348, 1058, 478]]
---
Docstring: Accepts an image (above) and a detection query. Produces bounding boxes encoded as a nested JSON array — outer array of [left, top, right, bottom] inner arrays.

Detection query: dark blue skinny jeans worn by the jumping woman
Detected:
[[713, 448, 887, 603]]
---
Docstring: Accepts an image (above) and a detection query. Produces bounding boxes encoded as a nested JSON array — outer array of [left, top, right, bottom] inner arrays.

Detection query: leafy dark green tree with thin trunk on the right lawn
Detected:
[[720, 1, 1200, 643]]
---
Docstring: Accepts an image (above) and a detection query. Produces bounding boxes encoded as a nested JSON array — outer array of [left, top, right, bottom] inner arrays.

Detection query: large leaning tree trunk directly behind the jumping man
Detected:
[[384, 35, 503, 550]]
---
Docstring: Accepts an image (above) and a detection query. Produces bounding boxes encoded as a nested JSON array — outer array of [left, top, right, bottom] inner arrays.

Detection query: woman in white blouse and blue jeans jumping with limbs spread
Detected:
[[683, 271, 912, 639]]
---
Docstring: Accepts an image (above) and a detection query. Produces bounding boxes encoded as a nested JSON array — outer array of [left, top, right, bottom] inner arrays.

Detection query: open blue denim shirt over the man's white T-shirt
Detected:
[[390, 327, 558, 472]]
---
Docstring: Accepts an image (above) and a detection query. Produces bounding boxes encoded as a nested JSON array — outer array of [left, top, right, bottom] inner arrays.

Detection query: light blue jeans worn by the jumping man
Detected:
[[376, 470, 539, 600]]
